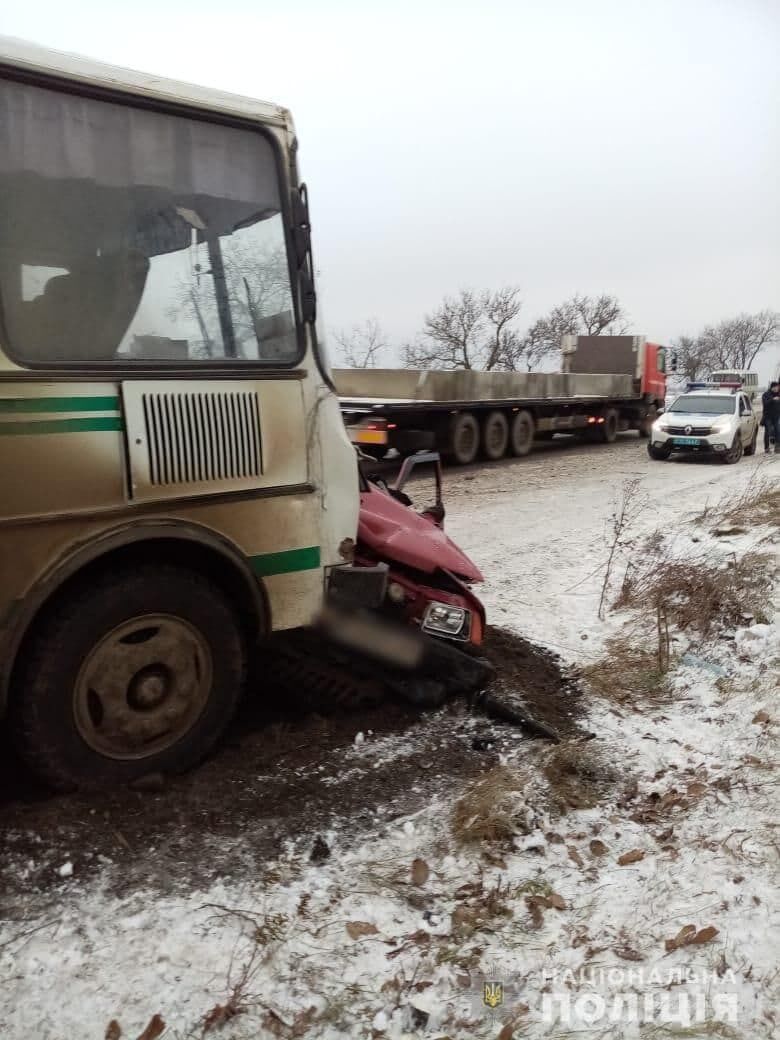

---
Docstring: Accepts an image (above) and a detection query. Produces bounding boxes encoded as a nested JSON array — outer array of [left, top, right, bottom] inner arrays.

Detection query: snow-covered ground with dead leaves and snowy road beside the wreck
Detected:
[[0, 440, 780, 1040]]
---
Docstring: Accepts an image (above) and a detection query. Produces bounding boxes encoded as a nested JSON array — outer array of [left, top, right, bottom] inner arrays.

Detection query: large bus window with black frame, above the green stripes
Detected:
[[0, 80, 298, 366]]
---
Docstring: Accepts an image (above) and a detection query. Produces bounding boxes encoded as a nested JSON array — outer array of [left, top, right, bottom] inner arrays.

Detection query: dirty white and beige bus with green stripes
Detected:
[[0, 40, 359, 787]]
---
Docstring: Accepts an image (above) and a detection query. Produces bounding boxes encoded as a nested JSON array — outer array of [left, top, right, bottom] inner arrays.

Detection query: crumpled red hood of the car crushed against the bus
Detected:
[[358, 485, 484, 581]]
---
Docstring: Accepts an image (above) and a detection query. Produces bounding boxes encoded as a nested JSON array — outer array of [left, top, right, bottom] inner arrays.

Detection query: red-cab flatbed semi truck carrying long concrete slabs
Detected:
[[334, 336, 667, 465]]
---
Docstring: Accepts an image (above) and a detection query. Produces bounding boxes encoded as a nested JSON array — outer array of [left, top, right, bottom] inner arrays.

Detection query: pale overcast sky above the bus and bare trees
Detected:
[[2, 0, 780, 378]]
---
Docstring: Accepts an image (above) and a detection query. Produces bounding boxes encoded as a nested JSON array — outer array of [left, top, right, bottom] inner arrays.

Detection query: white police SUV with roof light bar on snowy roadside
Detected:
[[647, 390, 758, 463]]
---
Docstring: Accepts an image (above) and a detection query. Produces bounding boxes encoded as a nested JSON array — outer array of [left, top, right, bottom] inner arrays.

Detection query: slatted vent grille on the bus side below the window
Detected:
[[141, 391, 263, 486]]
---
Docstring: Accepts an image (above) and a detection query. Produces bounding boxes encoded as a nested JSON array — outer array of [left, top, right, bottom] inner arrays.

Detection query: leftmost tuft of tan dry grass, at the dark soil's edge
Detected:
[[450, 765, 527, 844]]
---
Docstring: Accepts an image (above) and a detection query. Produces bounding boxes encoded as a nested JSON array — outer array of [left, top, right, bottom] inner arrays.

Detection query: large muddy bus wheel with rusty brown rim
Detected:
[[12, 565, 246, 789]]
